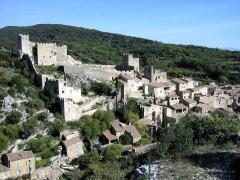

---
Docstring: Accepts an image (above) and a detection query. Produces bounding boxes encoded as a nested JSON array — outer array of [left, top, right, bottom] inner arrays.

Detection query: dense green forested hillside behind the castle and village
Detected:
[[0, 24, 240, 83]]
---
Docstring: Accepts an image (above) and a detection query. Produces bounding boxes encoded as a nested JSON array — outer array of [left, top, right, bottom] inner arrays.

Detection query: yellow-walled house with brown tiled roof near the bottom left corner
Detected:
[[3, 151, 35, 177]]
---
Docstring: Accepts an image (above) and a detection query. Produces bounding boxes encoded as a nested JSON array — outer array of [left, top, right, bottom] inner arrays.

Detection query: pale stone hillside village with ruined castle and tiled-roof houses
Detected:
[[0, 34, 240, 179]]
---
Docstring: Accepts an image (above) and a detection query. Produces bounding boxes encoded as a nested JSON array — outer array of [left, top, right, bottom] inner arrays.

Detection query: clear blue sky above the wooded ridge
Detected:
[[0, 0, 240, 50]]
